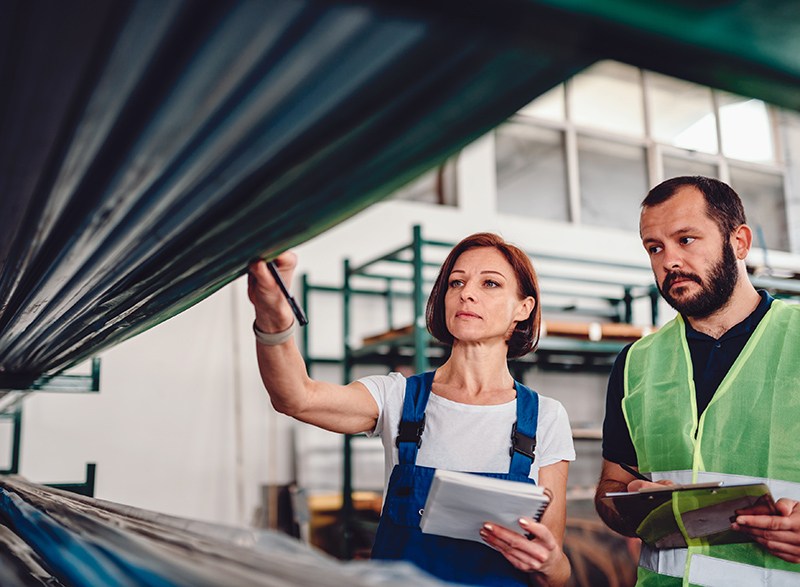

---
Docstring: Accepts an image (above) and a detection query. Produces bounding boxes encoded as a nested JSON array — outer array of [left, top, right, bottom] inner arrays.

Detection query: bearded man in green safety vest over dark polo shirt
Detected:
[[595, 177, 800, 586]]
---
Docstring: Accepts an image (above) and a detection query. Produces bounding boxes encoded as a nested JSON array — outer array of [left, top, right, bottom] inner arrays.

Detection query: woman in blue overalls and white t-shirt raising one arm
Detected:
[[248, 233, 575, 585]]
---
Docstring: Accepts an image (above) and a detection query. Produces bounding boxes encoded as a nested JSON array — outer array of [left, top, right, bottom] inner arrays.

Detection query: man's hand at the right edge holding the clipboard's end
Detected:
[[731, 498, 800, 563]]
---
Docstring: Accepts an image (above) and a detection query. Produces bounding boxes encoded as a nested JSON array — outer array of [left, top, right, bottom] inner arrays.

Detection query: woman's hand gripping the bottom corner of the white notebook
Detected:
[[480, 518, 565, 584]]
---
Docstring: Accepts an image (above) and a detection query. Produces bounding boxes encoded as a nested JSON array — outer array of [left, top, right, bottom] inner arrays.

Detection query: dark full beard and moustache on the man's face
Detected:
[[658, 242, 739, 318]]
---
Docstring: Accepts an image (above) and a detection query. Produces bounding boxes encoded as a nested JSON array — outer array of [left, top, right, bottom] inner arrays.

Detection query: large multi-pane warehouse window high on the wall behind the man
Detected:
[[495, 61, 791, 251]]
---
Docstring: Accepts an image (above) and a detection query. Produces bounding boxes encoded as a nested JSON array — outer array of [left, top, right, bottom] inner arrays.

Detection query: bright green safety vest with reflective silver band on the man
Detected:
[[622, 300, 800, 587]]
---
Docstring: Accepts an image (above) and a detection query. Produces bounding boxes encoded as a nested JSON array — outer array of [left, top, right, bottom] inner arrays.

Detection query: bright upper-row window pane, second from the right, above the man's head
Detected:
[[646, 72, 718, 153]]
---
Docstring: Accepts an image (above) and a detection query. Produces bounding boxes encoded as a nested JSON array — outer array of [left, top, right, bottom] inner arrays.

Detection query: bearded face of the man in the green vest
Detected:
[[640, 186, 739, 318]]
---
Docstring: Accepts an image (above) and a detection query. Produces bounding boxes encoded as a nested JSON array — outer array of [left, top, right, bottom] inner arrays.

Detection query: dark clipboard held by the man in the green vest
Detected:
[[600, 483, 778, 548]]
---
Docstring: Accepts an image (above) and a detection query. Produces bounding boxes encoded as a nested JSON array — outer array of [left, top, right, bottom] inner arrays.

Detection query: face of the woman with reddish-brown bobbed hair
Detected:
[[444, 247, 534, 342]]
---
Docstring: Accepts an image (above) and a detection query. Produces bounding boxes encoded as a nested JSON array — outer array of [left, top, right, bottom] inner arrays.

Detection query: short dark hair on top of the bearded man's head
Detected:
[[642, 175, 747, 237]]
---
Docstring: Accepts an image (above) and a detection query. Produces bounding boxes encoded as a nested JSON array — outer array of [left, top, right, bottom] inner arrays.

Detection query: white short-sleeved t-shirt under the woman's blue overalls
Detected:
[[359, 373, 575, 486]]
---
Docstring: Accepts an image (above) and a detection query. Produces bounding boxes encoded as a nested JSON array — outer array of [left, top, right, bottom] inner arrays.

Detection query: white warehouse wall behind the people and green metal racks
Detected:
[[7, 133, 800, 524]]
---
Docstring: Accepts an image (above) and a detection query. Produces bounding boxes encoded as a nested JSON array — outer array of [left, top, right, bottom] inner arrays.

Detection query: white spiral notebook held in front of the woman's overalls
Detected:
[[420, 470, 550, 542]]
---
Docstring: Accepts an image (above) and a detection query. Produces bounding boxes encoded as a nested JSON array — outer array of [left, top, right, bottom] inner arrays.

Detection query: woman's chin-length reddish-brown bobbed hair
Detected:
[[425, 232, 542, 359]]
